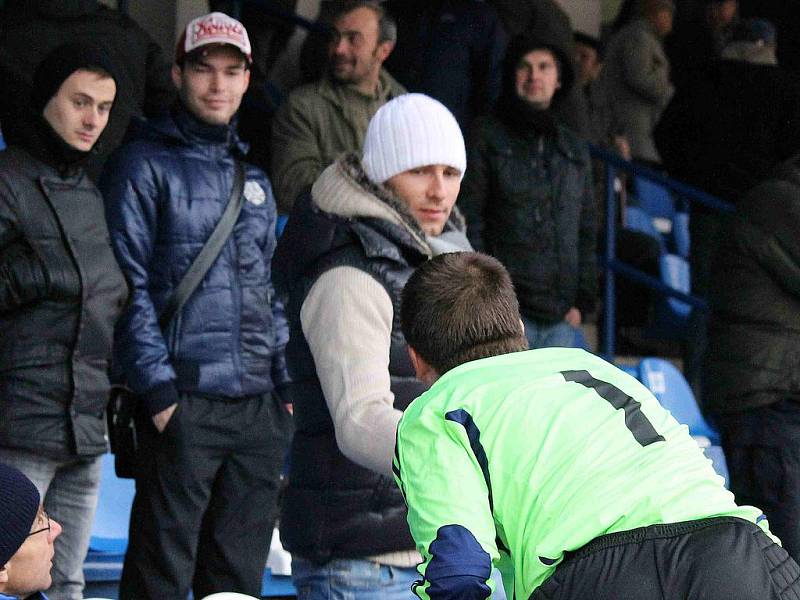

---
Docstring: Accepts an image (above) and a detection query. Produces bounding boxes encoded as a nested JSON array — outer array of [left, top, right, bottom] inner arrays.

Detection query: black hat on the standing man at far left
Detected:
[[31, 42, 119, 113]]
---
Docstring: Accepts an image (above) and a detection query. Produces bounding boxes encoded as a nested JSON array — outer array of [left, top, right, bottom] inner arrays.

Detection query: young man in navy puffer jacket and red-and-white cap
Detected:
[[101, 13, 290, 599]]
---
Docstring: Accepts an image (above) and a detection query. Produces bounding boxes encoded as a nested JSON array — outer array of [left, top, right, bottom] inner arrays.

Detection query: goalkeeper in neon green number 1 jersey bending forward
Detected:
[[394, 253, 800, 600]]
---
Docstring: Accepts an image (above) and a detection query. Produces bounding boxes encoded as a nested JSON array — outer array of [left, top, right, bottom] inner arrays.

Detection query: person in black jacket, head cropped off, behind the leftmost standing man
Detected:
[[0, 0, 175, 180]]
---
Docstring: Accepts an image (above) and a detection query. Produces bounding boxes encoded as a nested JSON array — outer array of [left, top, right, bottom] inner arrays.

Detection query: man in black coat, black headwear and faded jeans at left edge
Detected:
[[0, 44, 127, 599]]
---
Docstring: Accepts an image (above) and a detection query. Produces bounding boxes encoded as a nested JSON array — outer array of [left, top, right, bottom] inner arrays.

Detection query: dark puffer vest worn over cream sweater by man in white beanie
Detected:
[[276, 177, 438, 564]]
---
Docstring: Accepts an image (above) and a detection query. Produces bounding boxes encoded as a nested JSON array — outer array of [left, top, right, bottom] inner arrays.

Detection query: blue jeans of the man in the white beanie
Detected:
[[292, 556, 421, 600]]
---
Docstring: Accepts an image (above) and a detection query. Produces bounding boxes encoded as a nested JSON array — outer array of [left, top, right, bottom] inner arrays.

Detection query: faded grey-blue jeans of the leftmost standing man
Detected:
[[0, 448, 101, 600]]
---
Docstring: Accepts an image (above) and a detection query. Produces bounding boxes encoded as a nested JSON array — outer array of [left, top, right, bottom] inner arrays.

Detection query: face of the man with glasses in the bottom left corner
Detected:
[[0, 508, 61, 598]]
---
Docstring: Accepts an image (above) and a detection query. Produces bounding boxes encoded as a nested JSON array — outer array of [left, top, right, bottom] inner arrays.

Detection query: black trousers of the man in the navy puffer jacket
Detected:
[[120, 394, 291, 600]]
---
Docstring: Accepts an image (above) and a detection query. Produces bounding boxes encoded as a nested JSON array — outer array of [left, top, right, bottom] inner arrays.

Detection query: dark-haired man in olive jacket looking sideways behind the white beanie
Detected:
[[271, 0, 405, 213]]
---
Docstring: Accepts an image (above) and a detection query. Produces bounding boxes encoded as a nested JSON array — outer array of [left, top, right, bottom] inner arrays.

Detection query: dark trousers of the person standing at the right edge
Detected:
[[715, 398, 800, 560]]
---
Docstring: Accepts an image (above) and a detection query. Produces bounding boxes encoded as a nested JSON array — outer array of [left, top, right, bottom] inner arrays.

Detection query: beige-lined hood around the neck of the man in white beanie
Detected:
[[275, 153, 466, 288]]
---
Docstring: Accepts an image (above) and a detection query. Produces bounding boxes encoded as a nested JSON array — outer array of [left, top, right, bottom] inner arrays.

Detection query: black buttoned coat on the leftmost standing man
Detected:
[[0, 119, 127, 458]]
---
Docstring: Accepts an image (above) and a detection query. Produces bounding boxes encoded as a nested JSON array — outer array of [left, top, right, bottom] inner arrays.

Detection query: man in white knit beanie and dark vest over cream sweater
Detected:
[[275, 94, 469, 600]]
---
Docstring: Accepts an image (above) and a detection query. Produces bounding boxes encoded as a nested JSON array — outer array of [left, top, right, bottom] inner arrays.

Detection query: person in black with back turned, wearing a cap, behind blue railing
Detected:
[[655, 19, 800, 398]]
